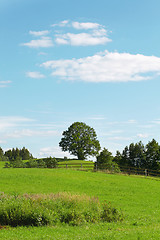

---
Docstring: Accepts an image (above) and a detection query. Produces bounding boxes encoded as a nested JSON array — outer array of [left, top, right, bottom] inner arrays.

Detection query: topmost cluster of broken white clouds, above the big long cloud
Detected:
[[21, 20, 111, 48]]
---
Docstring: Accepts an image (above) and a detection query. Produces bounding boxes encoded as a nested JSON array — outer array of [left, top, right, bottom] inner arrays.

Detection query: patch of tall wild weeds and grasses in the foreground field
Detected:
[[0, 193, 122, 227]]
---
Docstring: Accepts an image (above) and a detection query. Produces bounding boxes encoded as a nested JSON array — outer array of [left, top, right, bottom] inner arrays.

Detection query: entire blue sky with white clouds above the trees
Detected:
[[0, 0, 160, 157]]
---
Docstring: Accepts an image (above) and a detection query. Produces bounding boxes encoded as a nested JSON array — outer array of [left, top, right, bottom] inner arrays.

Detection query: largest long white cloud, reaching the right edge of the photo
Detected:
[[41, 51, 160, 82]]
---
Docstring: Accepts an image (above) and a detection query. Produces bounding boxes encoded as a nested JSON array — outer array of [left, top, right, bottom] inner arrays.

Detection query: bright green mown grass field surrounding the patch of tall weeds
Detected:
[[0, 162, 160, 240]]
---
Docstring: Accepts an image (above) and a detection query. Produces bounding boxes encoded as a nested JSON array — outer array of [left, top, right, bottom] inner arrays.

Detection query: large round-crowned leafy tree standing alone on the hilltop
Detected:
[[59, 122, 101, 160]]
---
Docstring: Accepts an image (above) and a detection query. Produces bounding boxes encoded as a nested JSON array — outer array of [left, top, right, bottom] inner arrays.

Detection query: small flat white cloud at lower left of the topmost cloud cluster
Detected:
[[22, 37, 53, 48]]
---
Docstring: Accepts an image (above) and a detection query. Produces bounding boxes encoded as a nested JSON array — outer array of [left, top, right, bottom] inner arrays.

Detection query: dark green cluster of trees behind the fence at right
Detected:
[[95, 139, 160, 170]]
